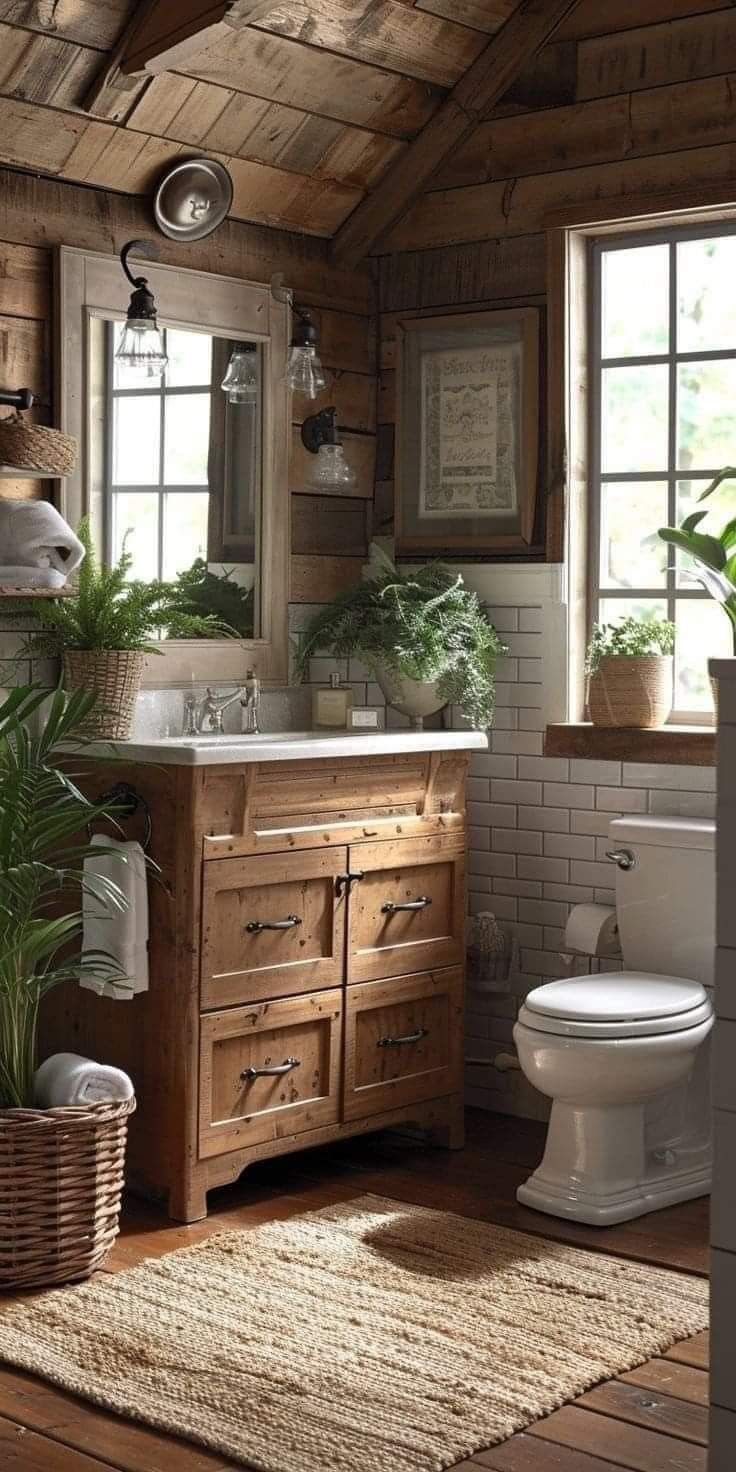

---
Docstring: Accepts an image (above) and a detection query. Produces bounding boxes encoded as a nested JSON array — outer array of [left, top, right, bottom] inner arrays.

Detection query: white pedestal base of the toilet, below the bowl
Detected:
[[517, 1101, 712, 1226]]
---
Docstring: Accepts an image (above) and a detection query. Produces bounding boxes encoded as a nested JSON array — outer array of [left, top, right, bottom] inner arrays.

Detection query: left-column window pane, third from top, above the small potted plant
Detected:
[[601, 480, 667, 587]]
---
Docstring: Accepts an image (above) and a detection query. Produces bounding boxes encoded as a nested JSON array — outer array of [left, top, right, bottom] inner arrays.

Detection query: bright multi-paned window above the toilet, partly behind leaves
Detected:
[[590, 227, 736, 721]]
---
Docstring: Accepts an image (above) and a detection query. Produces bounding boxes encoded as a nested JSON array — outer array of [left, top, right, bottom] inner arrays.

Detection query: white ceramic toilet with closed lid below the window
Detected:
[[514, 817, 715, 1226]]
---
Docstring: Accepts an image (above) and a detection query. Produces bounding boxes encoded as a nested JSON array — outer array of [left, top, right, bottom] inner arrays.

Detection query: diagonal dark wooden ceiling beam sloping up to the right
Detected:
[[333, 0, 580, 265]]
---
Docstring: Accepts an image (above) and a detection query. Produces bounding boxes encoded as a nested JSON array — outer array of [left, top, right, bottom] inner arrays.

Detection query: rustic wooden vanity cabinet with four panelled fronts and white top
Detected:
[[43, 732, 486, 1222]]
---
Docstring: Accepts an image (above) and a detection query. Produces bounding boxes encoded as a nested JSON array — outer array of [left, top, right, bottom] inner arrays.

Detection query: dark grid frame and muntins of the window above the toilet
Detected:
[[587, 221, 736, 726]]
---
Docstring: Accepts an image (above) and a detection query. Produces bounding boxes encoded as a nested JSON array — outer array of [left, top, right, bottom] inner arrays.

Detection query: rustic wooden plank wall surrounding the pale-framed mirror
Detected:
[[0, 169, 377, 602]]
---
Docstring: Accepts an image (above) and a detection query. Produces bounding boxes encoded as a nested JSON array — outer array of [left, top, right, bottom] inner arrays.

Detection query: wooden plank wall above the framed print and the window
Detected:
[[375, 0, 736, 555]]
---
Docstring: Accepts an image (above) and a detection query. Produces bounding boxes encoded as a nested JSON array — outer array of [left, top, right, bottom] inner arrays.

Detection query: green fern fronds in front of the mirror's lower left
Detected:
[[19, 517, 233, 657]]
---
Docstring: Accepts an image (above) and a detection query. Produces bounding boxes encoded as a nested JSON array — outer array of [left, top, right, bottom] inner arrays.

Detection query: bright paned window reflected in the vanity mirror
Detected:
[[105, 322, 212, 580]]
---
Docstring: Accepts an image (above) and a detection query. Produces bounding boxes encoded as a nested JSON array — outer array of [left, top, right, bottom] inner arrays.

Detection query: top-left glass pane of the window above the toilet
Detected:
[[601, 246, 670, 358]]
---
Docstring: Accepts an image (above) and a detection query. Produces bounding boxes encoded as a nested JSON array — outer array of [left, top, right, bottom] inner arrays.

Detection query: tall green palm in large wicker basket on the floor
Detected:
[[0, 686, 135, 1288]]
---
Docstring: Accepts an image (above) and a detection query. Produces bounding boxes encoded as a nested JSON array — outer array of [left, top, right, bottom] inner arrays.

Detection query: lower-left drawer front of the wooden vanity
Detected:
[[199, 991, 343, 1158]]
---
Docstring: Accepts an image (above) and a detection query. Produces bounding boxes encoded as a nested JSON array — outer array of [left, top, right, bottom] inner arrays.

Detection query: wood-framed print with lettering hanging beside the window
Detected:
[[396, 308, 539, 556]]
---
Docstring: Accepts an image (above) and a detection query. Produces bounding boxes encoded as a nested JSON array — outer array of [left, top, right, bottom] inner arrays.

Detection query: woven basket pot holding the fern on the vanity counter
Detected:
[[63, 649, 146, 740]]
